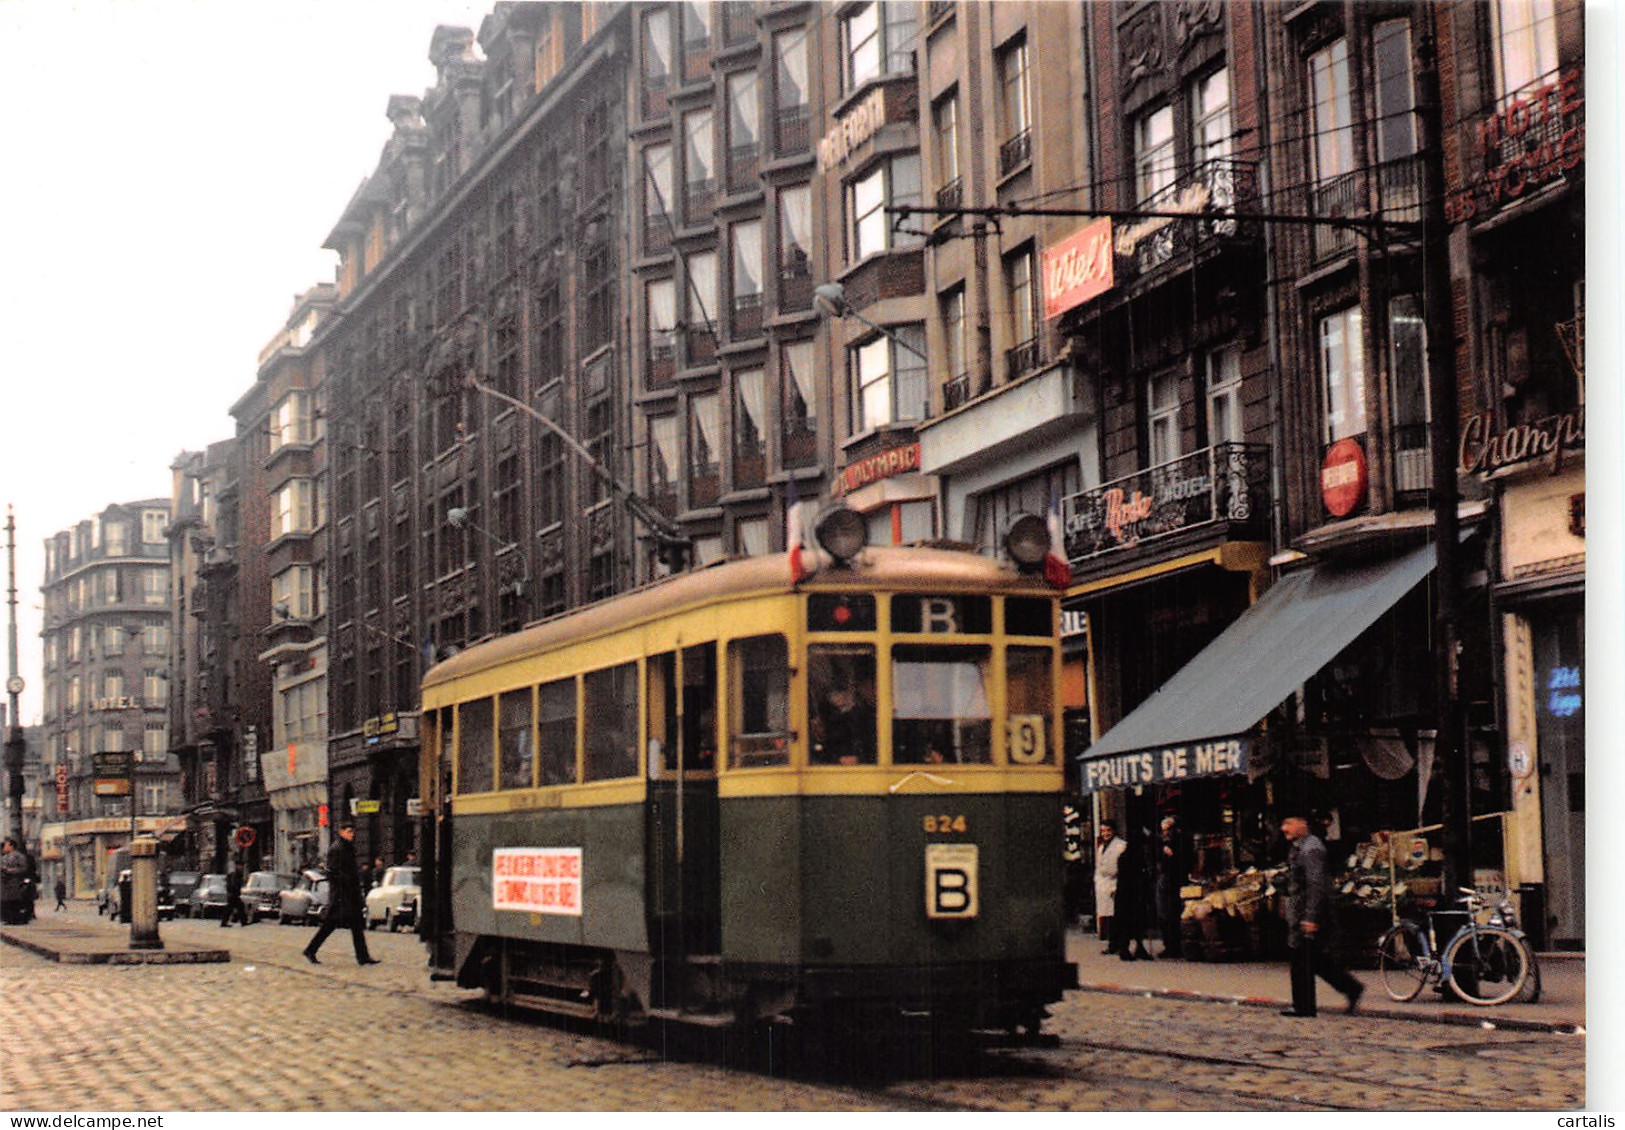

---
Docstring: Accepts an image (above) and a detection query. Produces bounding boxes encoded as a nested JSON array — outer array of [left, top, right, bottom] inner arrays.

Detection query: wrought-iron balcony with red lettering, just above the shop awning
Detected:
[[1061, 444, 1269, 566]]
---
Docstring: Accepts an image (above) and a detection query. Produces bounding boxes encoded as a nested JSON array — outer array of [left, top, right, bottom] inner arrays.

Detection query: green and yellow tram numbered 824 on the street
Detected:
[[421, 509, 1076, 1034]]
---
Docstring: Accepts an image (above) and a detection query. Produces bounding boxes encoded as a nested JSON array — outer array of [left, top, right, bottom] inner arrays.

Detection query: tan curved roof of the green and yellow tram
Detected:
[[423, 546, 1055, 686]]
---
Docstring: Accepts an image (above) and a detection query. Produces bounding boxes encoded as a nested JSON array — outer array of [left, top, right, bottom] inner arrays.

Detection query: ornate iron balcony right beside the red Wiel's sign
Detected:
[[1115, 161, 1261, 281]]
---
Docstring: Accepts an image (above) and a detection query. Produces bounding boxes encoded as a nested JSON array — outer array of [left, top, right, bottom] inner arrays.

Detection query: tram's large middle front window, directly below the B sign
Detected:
[[892, 644, 993, 766]]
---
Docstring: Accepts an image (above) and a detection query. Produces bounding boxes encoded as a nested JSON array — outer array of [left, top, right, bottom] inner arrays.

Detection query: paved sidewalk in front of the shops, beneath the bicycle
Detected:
[[1066, 927, 1586, 1032]]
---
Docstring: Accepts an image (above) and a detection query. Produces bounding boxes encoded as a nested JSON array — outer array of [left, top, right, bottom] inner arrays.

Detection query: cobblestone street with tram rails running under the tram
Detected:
[[0, 907, 1584, 1112]]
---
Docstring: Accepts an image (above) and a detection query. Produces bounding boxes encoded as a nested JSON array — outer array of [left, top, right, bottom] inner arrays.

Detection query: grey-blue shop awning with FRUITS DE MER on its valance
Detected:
[[1082, 543, 1435, 792]]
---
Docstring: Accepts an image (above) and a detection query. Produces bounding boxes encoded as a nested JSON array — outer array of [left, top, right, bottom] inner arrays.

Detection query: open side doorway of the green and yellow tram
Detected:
[[645, 644, 722, 959]]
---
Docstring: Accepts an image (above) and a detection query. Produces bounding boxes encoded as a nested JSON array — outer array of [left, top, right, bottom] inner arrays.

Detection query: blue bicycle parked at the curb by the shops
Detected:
[[1376, 888, 1539, 1006]]
